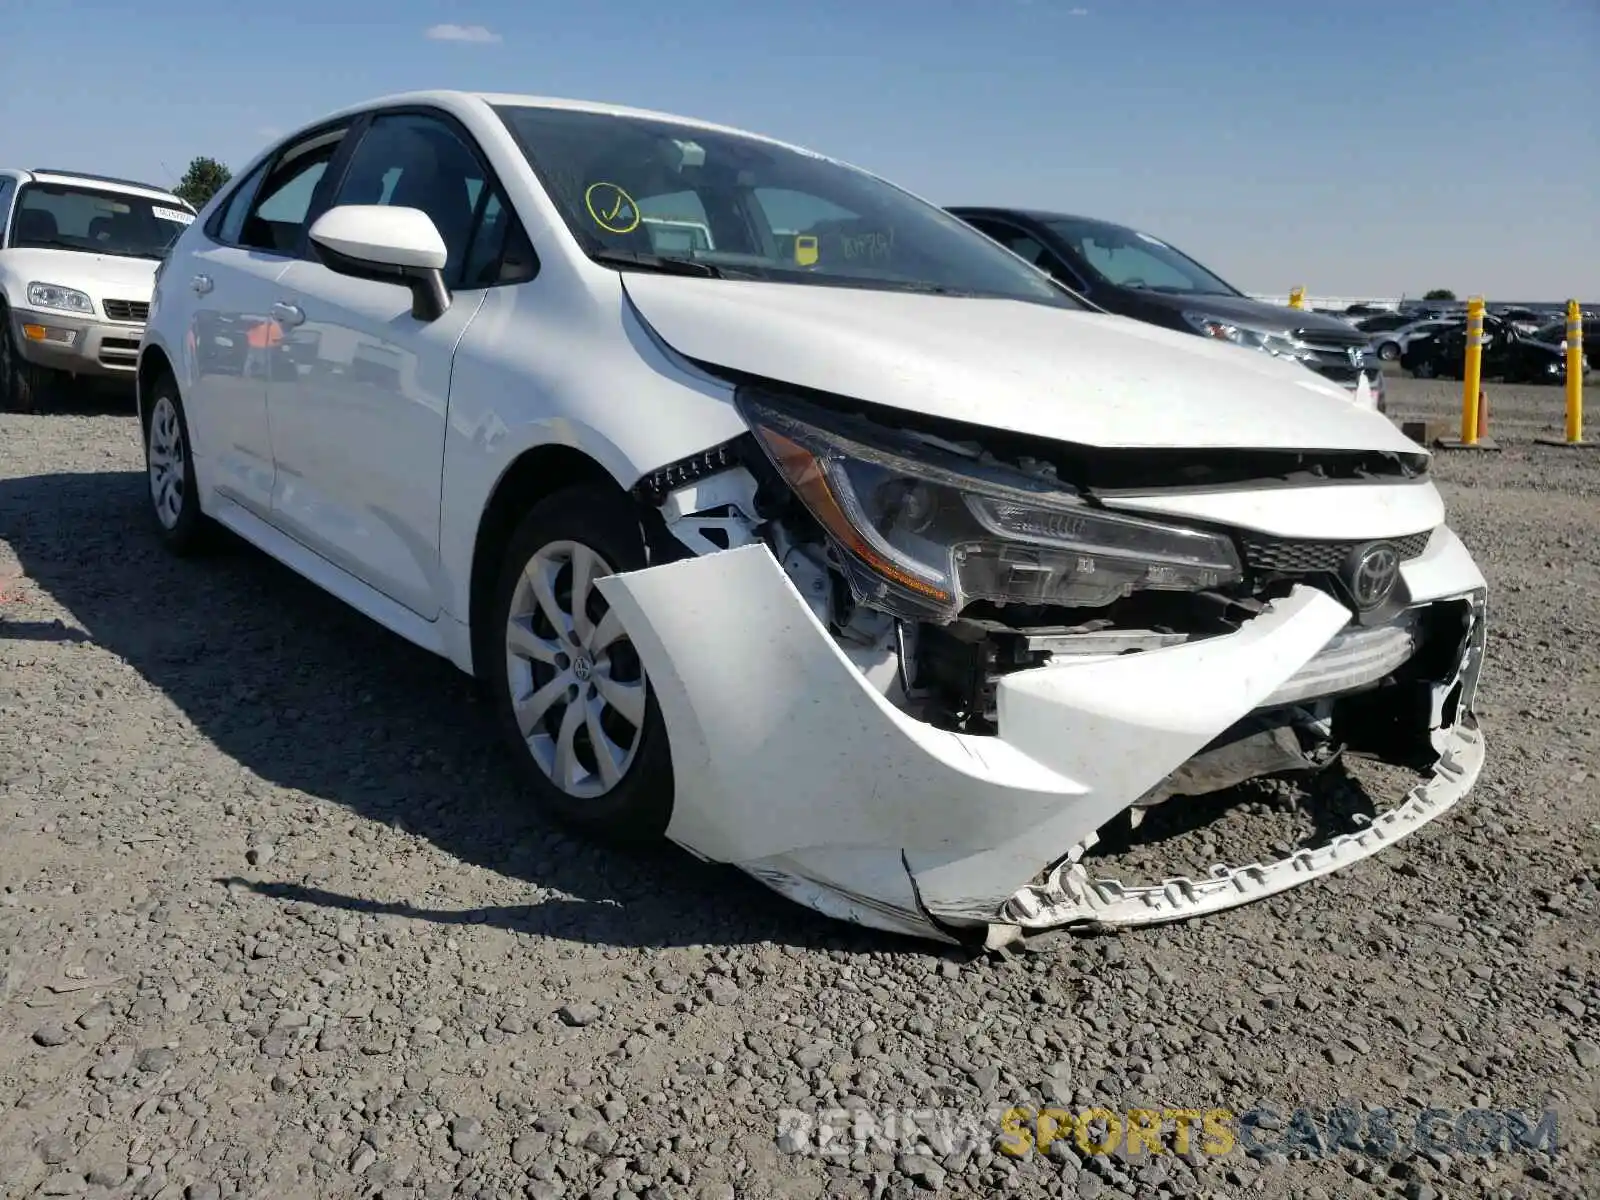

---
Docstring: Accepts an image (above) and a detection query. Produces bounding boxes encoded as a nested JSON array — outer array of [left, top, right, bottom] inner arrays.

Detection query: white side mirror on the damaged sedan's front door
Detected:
[[309, 205, 450, 322]]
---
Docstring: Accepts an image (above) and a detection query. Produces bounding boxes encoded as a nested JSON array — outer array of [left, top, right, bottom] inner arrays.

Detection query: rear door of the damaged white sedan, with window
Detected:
[[183, 125, 355, 520]]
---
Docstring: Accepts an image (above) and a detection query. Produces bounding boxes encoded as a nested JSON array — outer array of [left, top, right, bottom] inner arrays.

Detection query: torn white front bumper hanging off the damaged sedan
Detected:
[[598, 528, 1485, 946]]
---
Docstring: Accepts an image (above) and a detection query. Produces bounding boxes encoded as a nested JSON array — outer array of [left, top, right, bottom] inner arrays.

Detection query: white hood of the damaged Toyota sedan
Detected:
[[624, 274, 1424, 454]]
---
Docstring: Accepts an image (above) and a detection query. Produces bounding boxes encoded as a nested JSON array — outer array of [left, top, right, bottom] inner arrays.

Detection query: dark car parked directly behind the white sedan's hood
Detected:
[[949, 206, 1387, 411]]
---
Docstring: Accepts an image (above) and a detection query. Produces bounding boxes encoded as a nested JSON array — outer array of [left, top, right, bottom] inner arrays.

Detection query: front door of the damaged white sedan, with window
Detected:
[[267, 112, 488, 619]]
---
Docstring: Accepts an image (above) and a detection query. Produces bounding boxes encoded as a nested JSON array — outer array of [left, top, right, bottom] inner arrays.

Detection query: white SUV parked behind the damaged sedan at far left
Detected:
[[0, 168, 195, 410]]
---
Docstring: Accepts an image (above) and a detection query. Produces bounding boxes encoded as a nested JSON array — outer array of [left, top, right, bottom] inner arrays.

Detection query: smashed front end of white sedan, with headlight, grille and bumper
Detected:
[[598, 386, 1486, 947]]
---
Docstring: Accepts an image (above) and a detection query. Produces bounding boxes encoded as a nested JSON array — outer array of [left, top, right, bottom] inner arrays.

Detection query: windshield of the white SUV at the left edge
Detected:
[[11, 184, 195, 259]]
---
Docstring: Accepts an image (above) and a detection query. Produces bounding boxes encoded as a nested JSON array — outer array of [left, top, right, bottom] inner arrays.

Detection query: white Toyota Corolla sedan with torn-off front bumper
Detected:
[[138, 93, 1486, 947]]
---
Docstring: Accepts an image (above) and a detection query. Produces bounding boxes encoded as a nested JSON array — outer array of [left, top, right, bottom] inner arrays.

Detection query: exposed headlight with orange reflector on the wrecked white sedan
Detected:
[[739, 390, 1240, 621]]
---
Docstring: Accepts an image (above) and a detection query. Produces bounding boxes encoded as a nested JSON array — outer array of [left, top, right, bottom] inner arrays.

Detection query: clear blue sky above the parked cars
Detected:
[[0, 0, 1600, 299]]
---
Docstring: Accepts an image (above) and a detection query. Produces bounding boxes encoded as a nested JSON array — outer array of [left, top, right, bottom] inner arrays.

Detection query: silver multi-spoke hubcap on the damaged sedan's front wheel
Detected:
[[506, 541, 645, 798]]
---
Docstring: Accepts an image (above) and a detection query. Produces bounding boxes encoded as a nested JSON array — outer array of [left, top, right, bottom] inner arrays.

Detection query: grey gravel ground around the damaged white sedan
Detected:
[[0, 378, 1600, 1200]]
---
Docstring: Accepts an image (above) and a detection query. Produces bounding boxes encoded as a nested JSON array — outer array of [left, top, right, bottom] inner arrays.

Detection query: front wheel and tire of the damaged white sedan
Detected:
[[474, 485, 672, 845]]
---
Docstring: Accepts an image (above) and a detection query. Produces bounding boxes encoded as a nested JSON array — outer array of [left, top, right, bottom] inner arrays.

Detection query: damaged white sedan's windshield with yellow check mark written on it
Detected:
[[499, 106, 1078, 307]]
